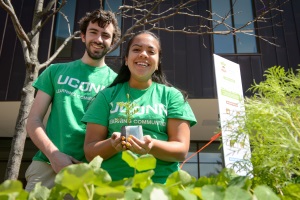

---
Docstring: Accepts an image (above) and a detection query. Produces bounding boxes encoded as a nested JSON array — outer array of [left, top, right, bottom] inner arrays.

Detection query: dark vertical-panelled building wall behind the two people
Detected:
[[0, 0, 300, 101]]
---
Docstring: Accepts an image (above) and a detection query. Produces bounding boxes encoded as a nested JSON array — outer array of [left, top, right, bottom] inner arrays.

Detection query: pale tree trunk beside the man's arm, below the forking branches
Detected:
[[4, 67, 38, 180]]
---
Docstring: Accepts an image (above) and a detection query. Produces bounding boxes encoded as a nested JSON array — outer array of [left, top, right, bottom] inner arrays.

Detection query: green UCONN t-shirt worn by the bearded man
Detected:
[[33, 60, 117, 162]]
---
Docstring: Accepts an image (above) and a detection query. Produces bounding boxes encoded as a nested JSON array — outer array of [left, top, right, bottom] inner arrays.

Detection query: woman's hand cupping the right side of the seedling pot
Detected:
[[126, 135, 153, 155]]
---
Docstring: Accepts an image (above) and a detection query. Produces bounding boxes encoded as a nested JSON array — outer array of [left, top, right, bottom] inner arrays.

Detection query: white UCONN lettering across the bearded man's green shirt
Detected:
[[57, 75, 105, 93]]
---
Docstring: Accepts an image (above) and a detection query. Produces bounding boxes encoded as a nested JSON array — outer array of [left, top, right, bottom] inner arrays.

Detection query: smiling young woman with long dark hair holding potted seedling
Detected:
[[82, 31, 196, 183]]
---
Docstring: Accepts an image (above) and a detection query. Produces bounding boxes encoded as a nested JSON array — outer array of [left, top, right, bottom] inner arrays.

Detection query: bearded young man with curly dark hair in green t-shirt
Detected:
[[25, 10, 120, 191]]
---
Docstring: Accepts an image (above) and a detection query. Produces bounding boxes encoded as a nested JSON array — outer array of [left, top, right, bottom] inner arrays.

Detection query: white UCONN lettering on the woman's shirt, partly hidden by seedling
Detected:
[[110, 103, 168, 115]]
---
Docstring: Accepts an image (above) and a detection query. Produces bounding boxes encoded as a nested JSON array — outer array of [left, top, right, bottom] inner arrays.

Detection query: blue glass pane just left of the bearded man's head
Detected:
[[54, 0, 76, 58]]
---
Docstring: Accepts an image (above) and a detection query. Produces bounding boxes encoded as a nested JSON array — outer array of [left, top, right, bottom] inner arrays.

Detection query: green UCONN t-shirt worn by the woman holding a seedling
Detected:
[[82, 82, 196, 183]]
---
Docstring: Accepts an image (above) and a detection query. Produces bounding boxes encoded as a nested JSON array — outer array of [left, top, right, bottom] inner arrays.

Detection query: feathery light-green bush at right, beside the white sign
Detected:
[[229, 66, 300, 195]]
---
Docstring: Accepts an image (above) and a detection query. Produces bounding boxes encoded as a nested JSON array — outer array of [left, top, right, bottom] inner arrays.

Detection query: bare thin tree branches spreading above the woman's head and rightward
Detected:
[[112, 0, 289, 46]]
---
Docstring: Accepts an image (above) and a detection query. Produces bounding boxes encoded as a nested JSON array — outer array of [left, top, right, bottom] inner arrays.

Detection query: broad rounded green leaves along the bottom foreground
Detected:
[[0, 151, 300, 200]]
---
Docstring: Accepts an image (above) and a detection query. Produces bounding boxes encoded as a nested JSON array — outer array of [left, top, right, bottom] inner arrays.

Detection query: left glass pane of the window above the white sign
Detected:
[[211, 0, 234, 53]]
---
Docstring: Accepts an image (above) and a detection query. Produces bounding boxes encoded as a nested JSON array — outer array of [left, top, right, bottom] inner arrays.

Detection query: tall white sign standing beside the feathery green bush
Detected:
[[214, 54, 252, 176]]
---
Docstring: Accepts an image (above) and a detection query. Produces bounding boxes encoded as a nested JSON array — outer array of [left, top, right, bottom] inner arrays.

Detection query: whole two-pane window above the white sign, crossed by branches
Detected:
[[211, 0, 257, 54]]
